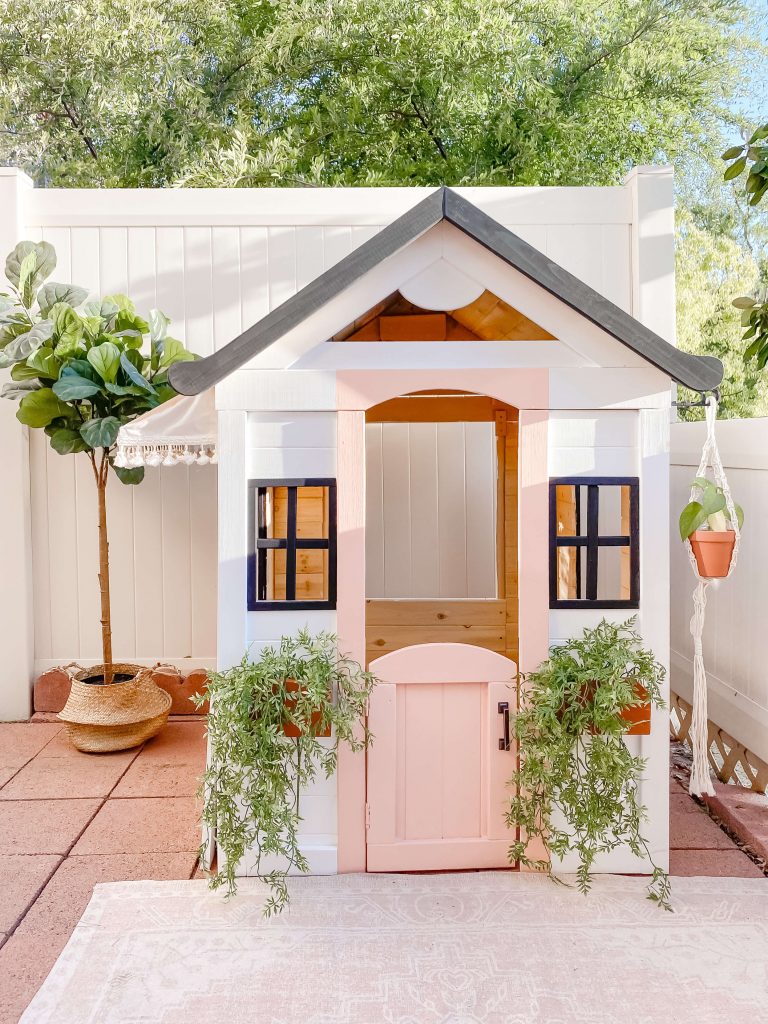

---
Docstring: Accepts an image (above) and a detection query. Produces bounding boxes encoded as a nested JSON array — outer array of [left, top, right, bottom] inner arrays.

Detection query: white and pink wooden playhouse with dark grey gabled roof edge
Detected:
[[120, 178, 722, 872]]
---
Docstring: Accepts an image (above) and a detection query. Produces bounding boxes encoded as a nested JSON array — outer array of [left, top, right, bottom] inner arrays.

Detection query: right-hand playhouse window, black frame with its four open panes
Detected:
[[549, 476, 640, 608]]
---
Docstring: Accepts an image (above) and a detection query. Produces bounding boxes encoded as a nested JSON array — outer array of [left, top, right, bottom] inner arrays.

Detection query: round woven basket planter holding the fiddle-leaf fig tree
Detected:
[[58, 664, 171, 754]]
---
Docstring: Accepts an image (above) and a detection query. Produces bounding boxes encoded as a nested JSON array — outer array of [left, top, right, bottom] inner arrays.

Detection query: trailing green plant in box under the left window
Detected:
[[195, 630, 375, 915]]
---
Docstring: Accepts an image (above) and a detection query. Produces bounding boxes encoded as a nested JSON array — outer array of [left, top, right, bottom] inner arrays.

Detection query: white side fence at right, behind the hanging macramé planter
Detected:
[[671, 419, 768, 761]]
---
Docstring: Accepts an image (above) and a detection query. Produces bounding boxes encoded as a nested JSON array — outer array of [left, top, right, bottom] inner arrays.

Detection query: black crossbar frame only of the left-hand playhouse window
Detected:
[[248, 476, 337, 611]]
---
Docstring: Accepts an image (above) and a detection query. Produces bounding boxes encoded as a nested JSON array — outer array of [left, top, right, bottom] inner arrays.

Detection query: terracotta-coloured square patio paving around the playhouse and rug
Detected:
[[0, 720, 762, 1024]]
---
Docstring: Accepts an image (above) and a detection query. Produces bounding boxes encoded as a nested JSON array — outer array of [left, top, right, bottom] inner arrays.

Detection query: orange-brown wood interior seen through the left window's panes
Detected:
[[267, 487, 328, 601]]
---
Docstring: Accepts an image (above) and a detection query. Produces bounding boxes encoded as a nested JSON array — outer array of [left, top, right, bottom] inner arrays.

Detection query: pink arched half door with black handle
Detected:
[[368, 643, 517, 871]]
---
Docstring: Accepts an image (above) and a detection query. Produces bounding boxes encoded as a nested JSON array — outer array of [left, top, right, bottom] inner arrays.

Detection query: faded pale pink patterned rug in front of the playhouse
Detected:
[[23, 872, 768, 1024]]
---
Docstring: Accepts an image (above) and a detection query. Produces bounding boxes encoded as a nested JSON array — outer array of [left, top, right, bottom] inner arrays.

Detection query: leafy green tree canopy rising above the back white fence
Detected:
[[0, 0, 757, 185]]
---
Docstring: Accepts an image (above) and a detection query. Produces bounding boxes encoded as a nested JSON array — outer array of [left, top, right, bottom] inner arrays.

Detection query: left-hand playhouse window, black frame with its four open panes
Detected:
[[248, 479, 336, 611]]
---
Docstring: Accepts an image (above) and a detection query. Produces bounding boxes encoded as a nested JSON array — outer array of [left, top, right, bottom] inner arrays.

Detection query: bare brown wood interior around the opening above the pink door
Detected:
[[366, 395, 519, 663]]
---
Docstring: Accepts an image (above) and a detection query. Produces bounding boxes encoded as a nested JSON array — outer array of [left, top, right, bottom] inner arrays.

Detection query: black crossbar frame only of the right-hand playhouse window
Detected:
[[549, 476, 640, 609]]
